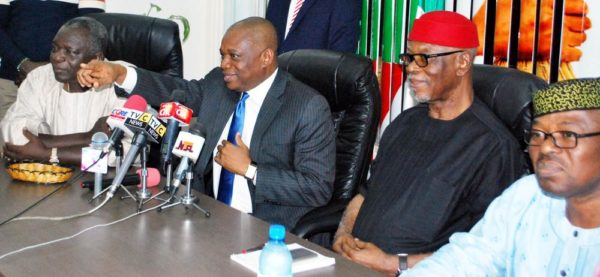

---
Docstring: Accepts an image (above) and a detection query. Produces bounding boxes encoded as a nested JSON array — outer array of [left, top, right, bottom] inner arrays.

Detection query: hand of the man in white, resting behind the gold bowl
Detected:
[[4, 129, 51, 162]]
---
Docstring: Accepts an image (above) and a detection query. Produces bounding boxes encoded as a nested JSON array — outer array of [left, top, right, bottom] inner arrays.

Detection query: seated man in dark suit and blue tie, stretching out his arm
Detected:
[[78, 17, 335, 228]]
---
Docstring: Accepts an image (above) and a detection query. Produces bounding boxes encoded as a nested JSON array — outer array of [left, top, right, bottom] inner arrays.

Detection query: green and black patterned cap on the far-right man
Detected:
[[533, 79, 600, 117]]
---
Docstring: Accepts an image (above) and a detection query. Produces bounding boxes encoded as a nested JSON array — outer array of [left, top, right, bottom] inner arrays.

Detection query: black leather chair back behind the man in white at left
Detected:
[[86, 13, 183, 78]]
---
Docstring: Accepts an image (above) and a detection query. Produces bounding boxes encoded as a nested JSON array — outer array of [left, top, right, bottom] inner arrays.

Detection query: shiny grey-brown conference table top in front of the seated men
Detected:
[[0, 163, 379, 276]]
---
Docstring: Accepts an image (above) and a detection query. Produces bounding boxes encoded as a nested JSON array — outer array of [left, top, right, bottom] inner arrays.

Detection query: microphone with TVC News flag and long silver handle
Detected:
[[106, 99, 167, 199]]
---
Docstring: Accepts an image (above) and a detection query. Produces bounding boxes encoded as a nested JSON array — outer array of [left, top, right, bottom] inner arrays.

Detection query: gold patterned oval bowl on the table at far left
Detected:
[[6, 163, 73, 184]]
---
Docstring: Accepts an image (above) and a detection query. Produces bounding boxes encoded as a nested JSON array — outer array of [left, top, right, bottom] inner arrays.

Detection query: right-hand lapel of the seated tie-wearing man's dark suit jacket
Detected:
[[250, 69, 288, 159]]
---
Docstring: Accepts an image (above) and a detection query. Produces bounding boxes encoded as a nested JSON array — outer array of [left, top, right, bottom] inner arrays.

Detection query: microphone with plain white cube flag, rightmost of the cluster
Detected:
[[171, 122, 206, 196]]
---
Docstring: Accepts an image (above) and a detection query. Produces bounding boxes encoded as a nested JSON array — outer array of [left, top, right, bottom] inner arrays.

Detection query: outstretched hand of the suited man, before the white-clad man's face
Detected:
[[77, 60, 127, 88]]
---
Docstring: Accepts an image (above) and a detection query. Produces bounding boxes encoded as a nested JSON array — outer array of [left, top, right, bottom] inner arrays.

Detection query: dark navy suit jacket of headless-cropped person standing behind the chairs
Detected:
[[266, 0, 362, 54]]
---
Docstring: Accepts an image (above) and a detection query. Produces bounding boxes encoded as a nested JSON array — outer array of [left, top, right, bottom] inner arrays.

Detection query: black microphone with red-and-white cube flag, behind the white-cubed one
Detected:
[[158, 89, 193, 175]]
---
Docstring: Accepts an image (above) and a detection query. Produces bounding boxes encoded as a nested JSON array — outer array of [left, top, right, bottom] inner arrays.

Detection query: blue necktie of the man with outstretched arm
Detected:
[[217, 92, 248, 205]]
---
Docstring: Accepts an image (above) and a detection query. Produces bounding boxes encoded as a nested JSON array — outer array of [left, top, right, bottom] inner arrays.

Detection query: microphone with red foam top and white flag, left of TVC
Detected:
[[106, 94, 148, 147]]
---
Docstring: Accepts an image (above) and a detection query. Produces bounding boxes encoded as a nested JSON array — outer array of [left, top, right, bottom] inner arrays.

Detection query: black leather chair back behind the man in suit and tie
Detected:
[[279, 49, 381, 200]]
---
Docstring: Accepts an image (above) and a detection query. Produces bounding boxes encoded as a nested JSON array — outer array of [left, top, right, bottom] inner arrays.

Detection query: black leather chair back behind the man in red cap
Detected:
[[473, 64, 548, 168]]
